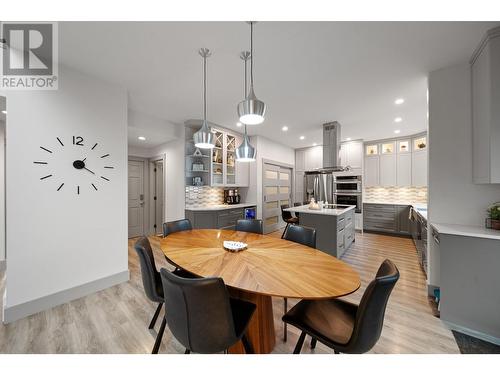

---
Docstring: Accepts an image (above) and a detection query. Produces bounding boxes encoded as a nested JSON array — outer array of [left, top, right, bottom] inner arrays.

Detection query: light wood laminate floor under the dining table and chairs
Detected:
[[0, 232, 459, 353]]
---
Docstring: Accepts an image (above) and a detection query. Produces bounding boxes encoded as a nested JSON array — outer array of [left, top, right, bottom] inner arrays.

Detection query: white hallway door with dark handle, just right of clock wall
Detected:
[[128, 160, 144, 238]]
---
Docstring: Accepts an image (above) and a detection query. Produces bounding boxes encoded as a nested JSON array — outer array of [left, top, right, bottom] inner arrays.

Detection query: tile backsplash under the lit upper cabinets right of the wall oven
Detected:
[[363, 187, 427, 203]]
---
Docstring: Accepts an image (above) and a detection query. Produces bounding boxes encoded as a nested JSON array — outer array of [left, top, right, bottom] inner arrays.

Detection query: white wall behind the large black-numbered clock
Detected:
[[0, 67, 128, 320]]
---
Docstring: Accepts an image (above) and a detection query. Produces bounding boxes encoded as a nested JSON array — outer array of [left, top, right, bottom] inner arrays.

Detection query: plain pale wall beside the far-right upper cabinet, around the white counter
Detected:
[[428, 63, 500, 286]]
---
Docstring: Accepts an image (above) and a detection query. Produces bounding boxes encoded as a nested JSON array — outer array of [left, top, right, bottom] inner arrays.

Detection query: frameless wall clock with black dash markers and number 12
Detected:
[[33, 135, 114, 195]]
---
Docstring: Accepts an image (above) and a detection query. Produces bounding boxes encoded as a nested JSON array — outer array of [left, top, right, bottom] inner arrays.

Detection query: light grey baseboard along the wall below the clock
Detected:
[[2, 270, 130, 323]]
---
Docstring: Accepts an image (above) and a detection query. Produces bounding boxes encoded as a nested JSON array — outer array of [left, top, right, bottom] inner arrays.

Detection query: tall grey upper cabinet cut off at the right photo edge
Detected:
[[471, 27, 500, 184]]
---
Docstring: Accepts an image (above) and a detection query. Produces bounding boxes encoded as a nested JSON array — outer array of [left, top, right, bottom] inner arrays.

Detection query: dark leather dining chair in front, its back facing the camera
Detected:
[[160, 268, 255, 354]]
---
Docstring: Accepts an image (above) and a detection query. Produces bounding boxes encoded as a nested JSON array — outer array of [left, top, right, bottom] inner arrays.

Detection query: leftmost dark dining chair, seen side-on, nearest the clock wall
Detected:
[[134, 237, 188, 354]]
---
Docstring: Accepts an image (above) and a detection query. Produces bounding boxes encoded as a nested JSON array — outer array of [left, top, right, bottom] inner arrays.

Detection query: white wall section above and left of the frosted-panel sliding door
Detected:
[[247, 136, 295, 219]]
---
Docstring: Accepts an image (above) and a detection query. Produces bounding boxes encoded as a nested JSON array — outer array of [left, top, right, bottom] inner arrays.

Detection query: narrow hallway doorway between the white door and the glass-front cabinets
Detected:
[[149, 158, 165, 234]]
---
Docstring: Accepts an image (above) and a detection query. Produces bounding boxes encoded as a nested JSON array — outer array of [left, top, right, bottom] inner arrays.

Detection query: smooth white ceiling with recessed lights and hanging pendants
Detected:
[[59, 22, 498, 147]]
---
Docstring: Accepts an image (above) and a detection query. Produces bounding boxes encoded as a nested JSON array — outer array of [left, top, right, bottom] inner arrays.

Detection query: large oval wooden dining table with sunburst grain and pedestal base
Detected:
[[160, 229, 360, 353]]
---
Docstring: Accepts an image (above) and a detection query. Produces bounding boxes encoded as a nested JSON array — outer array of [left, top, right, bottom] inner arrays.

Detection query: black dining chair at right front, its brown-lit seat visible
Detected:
[[283, 259, 399, 354]]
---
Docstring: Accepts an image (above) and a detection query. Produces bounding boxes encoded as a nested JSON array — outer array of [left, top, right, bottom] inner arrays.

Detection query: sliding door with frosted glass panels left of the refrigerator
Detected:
[[262, 161, 292, 234]]
